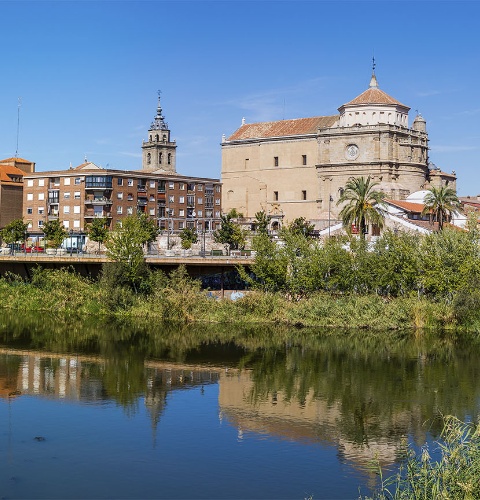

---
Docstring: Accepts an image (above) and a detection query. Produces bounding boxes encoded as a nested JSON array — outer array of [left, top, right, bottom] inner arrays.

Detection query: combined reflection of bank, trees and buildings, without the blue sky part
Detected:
[[0, 312, 480, 498]]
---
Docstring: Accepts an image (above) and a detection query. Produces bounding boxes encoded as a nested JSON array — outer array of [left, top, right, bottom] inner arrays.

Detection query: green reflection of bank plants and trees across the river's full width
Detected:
[[0, 315, 480, 443]]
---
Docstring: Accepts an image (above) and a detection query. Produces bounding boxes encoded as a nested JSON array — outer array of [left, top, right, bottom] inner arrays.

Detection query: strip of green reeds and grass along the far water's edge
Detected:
[[0, 269, 480, 332]]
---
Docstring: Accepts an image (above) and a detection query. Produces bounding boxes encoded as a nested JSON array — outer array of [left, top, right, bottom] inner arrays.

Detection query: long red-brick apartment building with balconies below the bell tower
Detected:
[[23, 161, 222, 233]]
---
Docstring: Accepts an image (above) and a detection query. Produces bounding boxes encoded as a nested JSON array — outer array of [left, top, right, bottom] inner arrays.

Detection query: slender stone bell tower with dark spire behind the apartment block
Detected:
[[142, 90, 177, 173]]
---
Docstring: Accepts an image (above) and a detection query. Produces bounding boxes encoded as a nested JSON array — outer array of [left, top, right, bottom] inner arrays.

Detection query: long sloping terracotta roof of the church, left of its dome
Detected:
[[228, 115, 338, 141]]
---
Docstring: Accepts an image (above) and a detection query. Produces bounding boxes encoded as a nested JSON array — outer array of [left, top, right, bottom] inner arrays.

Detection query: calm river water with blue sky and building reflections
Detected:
[[0, 318, 480, 499]]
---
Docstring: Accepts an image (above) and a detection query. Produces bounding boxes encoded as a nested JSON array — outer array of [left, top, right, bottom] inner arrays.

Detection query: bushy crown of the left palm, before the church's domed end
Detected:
[[337, 176, 385, 239]]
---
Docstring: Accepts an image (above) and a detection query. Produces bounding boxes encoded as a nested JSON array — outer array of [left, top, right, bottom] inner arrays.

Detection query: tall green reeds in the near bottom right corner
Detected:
[[362, 416, 480, 500]]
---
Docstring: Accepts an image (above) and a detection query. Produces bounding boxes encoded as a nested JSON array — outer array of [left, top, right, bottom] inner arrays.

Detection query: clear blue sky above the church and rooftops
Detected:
[[0, 0, 480, 196]]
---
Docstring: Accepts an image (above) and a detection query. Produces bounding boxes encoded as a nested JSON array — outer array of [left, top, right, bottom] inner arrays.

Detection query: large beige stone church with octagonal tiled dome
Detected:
[[221, 70, 456, 230]]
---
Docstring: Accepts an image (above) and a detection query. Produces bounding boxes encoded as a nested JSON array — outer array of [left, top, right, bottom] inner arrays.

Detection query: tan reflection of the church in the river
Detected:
[[219, 372, 420, 469]]
